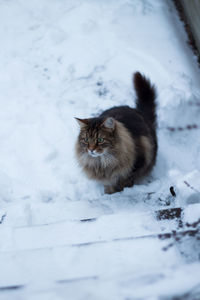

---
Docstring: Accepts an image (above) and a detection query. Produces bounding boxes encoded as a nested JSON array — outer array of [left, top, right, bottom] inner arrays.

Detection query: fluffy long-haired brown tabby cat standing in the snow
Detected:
[[75, 72, 157, 194]]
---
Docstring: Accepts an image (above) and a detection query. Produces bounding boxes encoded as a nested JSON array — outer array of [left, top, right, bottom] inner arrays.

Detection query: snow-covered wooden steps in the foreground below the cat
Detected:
[[0, 205, 200, 299]]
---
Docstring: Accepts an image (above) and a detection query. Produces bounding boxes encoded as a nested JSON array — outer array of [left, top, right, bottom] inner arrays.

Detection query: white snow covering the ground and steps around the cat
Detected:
[[0, 0, 200, 300]]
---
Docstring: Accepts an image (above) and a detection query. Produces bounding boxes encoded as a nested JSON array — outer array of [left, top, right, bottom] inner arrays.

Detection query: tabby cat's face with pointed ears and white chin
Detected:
[[76, 118, 115, 158]]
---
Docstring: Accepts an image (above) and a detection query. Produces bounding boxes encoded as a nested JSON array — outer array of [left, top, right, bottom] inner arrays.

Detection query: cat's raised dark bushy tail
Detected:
[[133, 72, 156, 128]]
